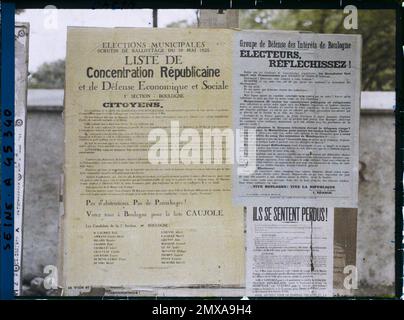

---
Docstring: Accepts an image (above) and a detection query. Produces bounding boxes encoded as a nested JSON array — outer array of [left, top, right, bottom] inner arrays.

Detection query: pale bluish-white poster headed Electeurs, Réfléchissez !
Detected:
[[233, 31, 361, 208]]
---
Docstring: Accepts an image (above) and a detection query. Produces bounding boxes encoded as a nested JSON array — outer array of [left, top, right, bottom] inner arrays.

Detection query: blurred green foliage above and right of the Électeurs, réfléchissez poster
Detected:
[[240, 10, 395, 91]]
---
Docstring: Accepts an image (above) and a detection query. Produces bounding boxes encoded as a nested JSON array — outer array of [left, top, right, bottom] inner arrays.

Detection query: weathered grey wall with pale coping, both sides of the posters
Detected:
[[23, 90, 395, 295]]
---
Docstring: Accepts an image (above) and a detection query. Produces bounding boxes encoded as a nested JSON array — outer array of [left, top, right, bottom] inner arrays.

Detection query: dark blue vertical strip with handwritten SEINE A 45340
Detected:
[[0, 3, 15, 300]]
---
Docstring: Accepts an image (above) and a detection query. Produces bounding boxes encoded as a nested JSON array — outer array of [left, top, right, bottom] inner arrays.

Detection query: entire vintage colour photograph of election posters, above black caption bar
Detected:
[[0, 1, 403, 315]]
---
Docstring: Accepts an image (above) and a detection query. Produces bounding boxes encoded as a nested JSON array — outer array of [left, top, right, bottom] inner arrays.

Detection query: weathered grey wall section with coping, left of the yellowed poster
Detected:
[[22, 90, 64, 283]]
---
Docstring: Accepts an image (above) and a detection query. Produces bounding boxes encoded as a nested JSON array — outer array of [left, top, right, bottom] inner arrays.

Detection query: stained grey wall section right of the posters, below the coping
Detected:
[[357, 112, 395, 295]]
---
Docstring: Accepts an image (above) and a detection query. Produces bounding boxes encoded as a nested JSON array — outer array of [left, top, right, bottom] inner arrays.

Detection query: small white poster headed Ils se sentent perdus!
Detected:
[[246, 206, 334, 297]]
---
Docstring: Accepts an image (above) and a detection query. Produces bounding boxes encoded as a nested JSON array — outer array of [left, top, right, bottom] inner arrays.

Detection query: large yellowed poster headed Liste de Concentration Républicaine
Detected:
[[63, 28, 244, 292]]
